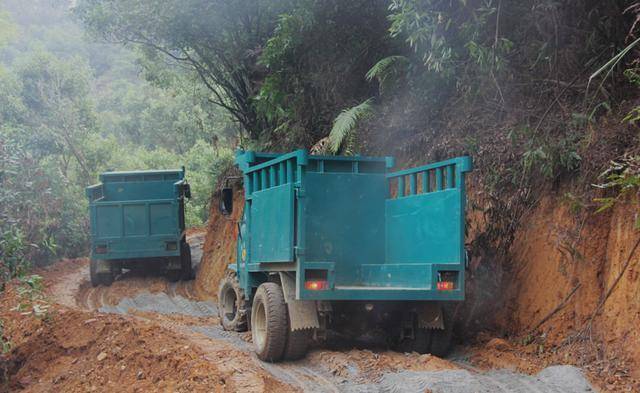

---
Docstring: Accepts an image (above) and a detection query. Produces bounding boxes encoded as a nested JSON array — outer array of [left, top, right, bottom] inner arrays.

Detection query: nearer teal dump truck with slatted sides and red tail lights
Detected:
[[218, 150, 471, 361]]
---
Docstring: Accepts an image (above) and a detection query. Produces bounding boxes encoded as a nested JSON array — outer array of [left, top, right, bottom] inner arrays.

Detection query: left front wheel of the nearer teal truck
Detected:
[[218, 271, 247, 332]]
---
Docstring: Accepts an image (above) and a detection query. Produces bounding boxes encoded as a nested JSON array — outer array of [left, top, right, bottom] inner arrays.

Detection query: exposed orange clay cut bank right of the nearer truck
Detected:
[[496, 196, 640, 391]]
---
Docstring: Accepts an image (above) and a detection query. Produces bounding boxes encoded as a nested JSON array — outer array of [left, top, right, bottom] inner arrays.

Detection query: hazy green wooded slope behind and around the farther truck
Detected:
[[0, 0, 236, 286]]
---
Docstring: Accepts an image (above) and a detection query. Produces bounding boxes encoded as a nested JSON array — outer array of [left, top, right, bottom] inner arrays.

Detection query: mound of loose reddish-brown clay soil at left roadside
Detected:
[[0, 280, 230, 392]]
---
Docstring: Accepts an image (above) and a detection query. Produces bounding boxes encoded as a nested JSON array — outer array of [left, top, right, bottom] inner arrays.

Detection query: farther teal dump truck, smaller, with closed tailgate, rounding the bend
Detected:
[[86, 168, 192, 286]]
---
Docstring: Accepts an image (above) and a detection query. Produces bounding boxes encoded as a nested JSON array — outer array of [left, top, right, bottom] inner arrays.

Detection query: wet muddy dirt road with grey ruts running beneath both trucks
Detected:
[[40, 231, 593, 393]]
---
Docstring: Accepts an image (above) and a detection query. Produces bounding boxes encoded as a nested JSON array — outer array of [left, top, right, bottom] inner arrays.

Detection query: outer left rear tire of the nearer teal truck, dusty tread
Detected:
[[251, 282, 288, 362]]
